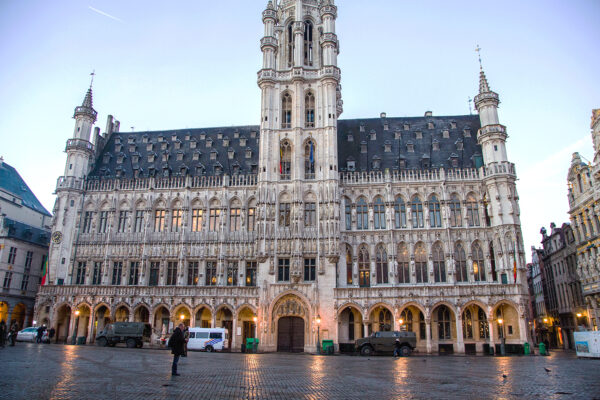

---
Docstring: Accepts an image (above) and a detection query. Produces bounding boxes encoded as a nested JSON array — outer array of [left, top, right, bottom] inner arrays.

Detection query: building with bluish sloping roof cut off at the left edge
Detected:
[[0, 157, 52, 327]]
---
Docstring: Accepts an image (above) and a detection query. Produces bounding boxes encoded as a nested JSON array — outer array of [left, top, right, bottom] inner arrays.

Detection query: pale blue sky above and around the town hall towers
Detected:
[[0, 0, 600, 259]]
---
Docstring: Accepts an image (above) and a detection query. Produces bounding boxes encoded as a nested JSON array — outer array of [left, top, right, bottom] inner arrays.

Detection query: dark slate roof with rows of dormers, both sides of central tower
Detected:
[[90, 115, 482, 179]]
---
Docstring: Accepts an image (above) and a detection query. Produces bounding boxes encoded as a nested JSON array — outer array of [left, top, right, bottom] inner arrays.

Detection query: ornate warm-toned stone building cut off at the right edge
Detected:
[[567, 109, 600, 330]]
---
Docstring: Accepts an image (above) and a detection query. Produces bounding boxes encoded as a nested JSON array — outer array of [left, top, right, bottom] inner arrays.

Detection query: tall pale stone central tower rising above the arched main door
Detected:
[[257, 0, 343, 338]]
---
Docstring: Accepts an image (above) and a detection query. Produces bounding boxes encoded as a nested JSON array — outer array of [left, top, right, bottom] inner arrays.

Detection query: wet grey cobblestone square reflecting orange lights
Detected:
[[0, 343, 600, 400]]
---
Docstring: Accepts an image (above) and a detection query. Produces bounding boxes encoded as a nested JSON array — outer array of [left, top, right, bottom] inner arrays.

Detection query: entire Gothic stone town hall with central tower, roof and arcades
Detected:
[[37, 0, 528, 353]]
